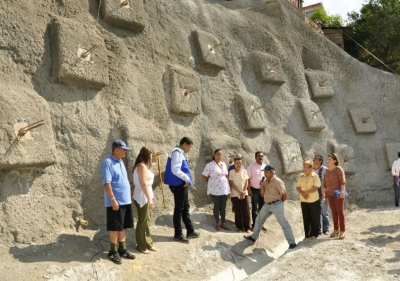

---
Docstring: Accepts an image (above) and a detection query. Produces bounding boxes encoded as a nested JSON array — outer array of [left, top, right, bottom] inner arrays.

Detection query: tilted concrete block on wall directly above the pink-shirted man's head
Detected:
[[236, 94, 267, 131]]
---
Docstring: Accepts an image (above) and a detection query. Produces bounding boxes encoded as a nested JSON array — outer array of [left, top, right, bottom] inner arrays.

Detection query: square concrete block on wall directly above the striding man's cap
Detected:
[[278, 140, 303, 174]]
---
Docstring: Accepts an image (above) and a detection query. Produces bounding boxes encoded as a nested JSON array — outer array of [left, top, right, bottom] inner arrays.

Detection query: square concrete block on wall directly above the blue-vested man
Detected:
[[169, 66, 201, 115]]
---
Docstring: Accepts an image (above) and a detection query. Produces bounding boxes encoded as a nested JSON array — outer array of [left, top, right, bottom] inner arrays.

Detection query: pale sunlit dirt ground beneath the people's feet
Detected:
[[0, 201, 400, 281]]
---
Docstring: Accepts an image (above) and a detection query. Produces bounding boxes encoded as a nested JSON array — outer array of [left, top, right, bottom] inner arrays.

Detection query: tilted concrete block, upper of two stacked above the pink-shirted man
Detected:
[[251, 52, 286, 85]]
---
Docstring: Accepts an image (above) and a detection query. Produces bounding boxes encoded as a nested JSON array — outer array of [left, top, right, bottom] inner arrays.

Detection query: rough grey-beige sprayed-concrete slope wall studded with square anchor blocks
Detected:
[[0, 0, 400, 244]]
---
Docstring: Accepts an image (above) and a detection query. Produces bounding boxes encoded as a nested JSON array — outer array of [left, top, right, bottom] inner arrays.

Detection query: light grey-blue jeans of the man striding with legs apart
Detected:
[[251, 200, 296, 244]]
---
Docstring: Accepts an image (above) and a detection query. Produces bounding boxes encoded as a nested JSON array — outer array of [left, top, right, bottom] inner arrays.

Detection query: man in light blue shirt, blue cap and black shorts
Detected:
[[101, 140, 135, 264]]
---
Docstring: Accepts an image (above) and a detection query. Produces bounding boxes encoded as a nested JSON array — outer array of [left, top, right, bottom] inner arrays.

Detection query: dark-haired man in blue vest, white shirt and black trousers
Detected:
[[164, 137, 200, 243]]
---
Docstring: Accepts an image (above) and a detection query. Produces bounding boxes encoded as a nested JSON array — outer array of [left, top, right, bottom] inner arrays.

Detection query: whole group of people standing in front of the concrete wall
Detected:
[[102, 137, 345, 264]]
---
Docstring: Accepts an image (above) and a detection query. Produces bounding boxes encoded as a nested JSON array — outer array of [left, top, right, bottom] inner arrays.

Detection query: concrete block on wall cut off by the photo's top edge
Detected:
[[101, 0, 146, 32]]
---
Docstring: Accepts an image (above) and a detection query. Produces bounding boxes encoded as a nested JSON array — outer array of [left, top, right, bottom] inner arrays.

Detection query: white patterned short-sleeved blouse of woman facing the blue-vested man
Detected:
[[203, 161, 231, 195]]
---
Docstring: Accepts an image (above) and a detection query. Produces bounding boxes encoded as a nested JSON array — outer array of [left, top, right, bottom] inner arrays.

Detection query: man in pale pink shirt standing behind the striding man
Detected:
[[247, 151, 266, 230]]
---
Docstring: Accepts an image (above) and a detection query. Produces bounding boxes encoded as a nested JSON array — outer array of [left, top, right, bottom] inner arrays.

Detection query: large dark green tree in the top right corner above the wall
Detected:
[[348, 0, 400, 71]]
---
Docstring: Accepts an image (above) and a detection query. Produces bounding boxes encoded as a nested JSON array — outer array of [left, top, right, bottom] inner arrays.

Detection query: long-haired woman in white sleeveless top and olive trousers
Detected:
[[133, 146, 156, 254]]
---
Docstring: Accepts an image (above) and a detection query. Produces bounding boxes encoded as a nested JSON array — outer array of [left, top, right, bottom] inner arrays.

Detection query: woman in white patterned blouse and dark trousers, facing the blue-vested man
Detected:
[[202, 149, 231, 231]]
